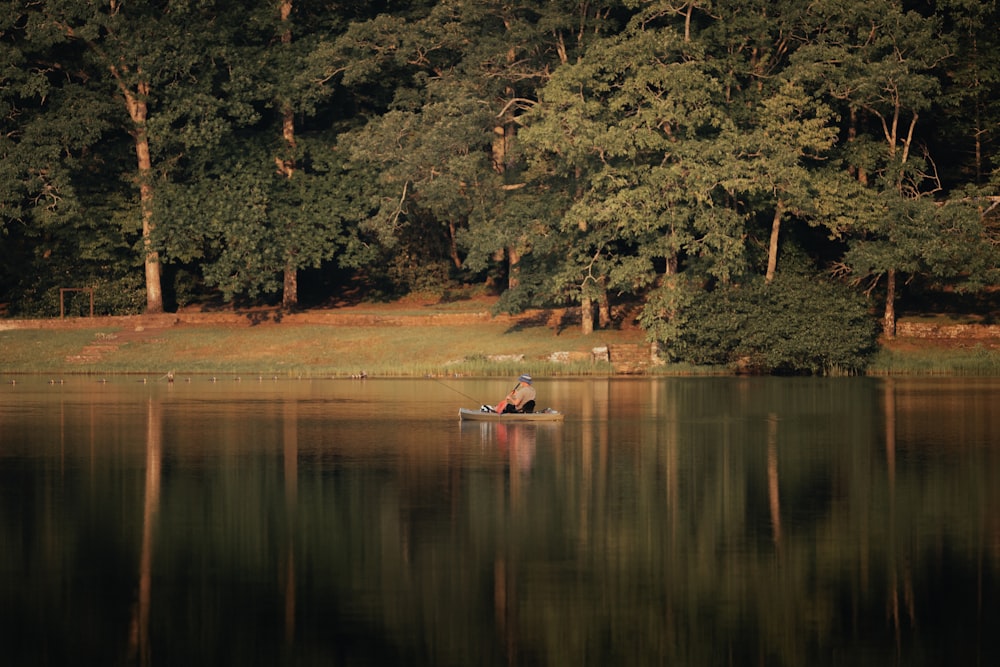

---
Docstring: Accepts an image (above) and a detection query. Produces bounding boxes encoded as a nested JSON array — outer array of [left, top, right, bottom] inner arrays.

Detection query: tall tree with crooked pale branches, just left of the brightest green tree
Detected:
[[332, 0, 614, 298]]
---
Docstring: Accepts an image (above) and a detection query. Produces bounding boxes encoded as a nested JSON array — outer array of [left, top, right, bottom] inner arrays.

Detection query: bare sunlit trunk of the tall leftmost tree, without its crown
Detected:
[[117, 74, 163, 314]]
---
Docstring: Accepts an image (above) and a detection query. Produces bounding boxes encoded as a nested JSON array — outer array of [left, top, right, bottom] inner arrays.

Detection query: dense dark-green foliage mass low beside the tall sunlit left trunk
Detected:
[[154, 127, 364, 300]]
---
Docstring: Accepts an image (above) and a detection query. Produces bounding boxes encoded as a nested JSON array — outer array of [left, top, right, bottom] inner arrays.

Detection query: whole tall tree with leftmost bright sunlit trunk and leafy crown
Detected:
[[28, 0, 258, 313]]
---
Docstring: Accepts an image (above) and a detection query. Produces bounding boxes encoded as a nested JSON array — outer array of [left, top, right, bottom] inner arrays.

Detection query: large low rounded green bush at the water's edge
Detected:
[[654, 274, 878, 374]]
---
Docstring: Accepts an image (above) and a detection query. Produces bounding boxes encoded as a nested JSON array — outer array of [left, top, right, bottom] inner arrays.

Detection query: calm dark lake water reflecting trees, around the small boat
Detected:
[[0, 377, 1000, 667]]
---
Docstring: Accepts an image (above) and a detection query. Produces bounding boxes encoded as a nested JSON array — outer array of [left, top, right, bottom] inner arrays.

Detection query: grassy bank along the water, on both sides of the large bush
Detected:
[[0, 309, 1000, 377]]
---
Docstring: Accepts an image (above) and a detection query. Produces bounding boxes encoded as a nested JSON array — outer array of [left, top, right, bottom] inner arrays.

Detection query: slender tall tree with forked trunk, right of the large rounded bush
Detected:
[[795, 0, 952, 337]]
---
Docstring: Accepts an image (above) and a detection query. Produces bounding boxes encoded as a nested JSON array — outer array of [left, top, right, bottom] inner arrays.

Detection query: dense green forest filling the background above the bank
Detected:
[[0, 0, 1000, 372]]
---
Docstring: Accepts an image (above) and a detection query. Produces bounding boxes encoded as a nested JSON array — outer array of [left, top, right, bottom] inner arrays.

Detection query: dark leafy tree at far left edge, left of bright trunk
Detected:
[[0, 3, 146, 314]]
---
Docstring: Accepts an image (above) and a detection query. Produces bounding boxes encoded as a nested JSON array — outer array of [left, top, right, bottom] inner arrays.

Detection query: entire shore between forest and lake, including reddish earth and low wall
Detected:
[[0, 298, 1000, 377]]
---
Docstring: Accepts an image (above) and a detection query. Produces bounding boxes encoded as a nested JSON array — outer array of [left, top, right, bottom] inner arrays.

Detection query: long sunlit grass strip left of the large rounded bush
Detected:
[[0, 322, 632, 377]]
